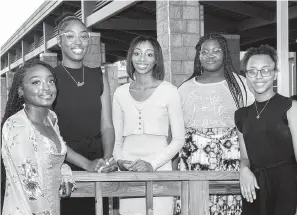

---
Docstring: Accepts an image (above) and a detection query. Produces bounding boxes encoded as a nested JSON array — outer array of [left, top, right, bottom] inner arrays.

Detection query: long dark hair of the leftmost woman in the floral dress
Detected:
[[1, 59, 57, 128]]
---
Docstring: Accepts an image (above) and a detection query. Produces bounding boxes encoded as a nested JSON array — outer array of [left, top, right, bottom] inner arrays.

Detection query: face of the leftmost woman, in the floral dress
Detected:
[[18, 65, 57, 107]]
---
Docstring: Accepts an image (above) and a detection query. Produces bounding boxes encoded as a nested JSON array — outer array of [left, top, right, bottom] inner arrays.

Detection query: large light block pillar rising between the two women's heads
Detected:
[[156, 0, 204, 86]]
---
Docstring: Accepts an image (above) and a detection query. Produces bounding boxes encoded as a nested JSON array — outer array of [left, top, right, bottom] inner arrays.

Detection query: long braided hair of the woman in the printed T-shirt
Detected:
[[186, 33, 247, 108]]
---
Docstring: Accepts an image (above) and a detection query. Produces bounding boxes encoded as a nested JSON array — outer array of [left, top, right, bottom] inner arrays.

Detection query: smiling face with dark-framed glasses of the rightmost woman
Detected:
[[246, 54, 277, 94]]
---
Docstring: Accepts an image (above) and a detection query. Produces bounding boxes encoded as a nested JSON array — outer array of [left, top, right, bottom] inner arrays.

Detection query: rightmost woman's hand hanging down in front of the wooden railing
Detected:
[[240, 167, 260, 203]]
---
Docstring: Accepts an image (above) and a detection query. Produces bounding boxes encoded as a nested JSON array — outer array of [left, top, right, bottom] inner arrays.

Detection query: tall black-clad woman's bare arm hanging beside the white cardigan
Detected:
[[101, 73, 115, 159]]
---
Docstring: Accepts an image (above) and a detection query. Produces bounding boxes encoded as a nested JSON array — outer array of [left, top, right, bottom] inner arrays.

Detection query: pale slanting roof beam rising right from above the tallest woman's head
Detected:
[[86, 0, 138, 28]]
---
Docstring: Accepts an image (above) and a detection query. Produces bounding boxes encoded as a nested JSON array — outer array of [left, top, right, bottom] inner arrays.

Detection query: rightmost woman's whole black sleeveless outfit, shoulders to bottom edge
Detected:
[[235, 94, 297, 215]]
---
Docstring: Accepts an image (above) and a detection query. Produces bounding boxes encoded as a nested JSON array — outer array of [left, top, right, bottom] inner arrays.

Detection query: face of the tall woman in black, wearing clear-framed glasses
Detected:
[[58, 20, 89, 62]]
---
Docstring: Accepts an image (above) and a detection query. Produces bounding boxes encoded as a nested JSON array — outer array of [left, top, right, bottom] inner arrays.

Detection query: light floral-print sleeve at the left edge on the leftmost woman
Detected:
[[2, 120, 51, 215]]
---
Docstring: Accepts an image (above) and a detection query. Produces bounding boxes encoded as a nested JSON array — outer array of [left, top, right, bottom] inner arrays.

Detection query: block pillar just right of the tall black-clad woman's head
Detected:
[[84, 32, 102, 68]]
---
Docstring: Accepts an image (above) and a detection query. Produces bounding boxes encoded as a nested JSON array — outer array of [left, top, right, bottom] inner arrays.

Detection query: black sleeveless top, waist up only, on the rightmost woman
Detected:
[[235, 94, 295, 167]]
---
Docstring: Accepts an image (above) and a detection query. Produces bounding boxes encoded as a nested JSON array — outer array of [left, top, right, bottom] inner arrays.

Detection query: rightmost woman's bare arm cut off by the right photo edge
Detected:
[[287, 101, 297, 160]]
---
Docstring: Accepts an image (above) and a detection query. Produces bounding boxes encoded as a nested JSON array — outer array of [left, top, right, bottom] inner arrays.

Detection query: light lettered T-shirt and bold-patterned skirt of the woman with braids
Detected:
[[175, 75, 253, 215]]
